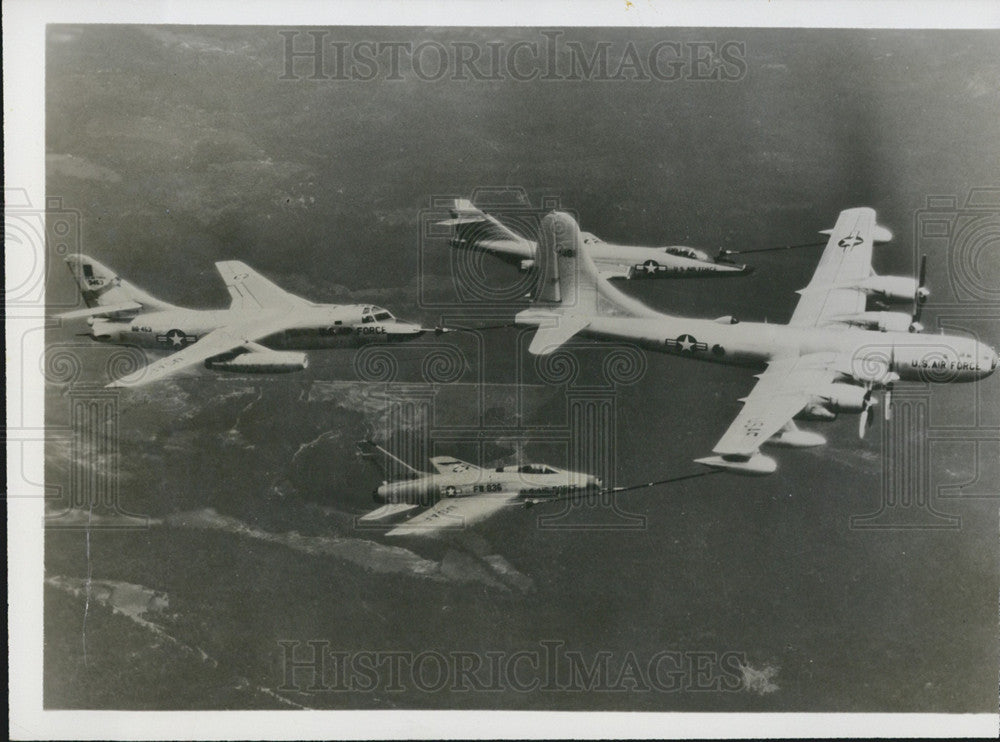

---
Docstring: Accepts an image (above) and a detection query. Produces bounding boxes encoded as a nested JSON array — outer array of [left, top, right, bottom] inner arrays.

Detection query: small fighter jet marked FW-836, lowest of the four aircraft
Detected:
[[358, 441, 601, 536]]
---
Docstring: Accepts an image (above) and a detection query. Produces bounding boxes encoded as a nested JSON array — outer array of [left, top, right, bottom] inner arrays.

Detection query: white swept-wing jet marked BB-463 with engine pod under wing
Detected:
[[59, 255, 427, 387]]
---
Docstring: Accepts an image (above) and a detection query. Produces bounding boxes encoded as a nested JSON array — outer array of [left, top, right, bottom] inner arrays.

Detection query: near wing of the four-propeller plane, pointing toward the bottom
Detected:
[[712, 353, 838, 460]]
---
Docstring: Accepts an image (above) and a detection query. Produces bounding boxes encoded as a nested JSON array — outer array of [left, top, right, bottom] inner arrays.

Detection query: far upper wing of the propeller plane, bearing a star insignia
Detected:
[[788, 207, 876, 327]]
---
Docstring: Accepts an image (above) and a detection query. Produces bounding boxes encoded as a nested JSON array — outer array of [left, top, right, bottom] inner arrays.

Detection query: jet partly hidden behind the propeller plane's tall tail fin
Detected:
[[439, 199, 753, 280]]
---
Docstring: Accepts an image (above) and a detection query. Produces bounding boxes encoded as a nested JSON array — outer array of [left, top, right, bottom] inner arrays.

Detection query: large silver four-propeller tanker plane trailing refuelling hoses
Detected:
[[515, 208, 997, 474]]
